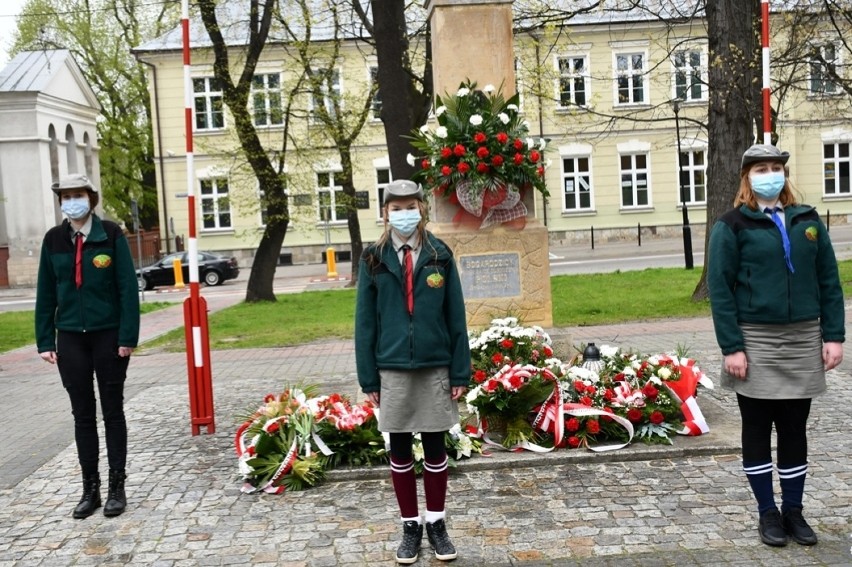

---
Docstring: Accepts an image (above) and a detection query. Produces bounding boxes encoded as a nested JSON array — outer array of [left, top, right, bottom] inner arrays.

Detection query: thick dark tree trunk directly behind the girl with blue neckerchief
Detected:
[[692, 0, 761, 301]]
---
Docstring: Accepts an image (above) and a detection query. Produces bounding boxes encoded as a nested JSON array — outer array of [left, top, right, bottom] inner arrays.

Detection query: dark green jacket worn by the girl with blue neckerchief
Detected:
[[707, 205, 846, 354]]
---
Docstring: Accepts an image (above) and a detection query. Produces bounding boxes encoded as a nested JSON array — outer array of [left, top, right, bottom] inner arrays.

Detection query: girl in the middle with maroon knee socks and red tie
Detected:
[[355, 180, 470, 564]]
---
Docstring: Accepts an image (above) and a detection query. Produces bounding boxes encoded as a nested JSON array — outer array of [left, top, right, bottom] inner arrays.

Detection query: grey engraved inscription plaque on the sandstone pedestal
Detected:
[[459, 253, 521, 299]]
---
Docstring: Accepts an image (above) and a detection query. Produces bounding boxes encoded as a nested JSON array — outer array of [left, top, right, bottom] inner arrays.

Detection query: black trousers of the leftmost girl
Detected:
[[56, 329, 130, 475]]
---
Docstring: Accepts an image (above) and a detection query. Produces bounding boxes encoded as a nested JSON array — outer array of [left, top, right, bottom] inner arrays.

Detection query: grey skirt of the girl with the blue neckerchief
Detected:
[[722, 320, 825, 400]]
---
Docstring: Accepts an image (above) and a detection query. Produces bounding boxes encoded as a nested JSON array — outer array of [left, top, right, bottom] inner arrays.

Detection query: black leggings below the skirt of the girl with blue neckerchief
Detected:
[[737, 394, 811, 465]]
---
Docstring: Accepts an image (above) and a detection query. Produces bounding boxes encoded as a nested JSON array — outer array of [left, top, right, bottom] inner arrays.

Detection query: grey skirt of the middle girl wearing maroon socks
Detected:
[[379, 367, 459, 433]]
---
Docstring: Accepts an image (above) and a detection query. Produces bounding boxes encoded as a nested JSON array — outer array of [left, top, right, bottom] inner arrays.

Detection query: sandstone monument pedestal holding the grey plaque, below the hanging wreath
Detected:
[[429, 197, 553, 329]]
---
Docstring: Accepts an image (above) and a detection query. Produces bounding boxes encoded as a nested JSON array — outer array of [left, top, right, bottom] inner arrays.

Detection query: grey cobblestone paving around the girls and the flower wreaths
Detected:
[[0, 240, 852, 567]]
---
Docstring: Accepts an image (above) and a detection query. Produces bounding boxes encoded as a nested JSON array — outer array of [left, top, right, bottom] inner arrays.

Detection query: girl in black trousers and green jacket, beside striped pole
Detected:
[[35, 174, 139, 518]]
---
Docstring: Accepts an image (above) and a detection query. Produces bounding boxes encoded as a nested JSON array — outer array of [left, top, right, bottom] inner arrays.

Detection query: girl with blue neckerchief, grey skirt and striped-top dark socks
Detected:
[[707, 144, 845, 546]]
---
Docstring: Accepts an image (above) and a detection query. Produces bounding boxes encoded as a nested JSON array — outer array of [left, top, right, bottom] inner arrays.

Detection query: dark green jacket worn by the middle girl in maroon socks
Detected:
[[355, 233, 470, 393]]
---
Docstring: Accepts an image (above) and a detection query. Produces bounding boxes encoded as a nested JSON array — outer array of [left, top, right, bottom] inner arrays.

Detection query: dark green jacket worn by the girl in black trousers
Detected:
[[35, 215, 139, 352]]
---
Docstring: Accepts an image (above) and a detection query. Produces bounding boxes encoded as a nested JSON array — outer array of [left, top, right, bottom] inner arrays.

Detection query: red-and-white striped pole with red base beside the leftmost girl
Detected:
[[181, 0, 216, 435]]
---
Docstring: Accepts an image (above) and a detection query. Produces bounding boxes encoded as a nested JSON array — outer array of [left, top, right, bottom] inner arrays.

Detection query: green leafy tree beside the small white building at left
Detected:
[[12, 0, 180, 228]]
